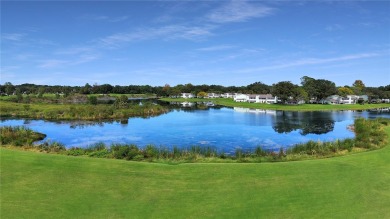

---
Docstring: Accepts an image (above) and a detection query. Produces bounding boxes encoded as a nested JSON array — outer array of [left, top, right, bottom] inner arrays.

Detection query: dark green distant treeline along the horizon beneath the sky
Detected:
[[0, 76, 390, 99]]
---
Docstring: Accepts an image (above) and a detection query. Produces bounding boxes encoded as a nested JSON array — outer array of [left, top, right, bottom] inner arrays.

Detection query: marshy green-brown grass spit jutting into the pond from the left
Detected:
[[0, 101, 169, 120]]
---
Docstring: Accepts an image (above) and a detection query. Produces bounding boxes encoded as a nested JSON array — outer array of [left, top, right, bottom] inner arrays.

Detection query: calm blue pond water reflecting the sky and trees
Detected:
[[0, 107, 390, 152]]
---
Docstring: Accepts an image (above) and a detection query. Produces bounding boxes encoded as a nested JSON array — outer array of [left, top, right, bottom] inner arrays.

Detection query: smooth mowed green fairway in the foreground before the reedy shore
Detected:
[[0, 128, 390, 218]]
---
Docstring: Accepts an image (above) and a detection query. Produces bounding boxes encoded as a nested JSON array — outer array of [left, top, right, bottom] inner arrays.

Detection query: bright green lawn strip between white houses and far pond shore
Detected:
[[160, 98, 390, 111]]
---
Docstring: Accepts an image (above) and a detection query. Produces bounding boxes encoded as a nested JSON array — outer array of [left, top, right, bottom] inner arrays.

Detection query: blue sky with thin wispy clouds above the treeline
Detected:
[[1, 0, 390, 87]]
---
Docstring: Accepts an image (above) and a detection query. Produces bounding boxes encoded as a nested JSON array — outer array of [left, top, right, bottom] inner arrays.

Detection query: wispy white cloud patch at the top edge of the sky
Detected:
[[207, 0, 274, 23]]
